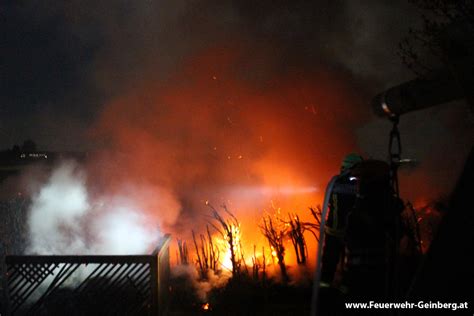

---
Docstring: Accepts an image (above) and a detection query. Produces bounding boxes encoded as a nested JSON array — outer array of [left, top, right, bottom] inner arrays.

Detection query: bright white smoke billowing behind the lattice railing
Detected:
[[27, 162, 160, 255]]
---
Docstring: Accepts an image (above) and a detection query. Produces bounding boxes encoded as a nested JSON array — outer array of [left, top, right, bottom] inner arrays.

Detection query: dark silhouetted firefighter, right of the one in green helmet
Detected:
[[344, 160, 403, 299]]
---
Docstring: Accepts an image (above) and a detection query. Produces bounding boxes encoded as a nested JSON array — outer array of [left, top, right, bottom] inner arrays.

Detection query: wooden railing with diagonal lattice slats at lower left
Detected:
[[1, 235, 170, 316]]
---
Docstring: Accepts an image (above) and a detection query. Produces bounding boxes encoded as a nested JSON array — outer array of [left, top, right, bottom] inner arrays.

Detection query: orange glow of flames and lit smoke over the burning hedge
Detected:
[[90, 43, 363, 272]]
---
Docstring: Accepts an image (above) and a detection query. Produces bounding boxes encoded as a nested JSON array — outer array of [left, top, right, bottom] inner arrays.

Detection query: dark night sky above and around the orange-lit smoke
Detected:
[[0, 0, 472, 200]]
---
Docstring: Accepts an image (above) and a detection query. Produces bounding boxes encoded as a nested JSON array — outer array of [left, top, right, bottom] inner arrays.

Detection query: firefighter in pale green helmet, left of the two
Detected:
[[320, 153, 363, 291]]
